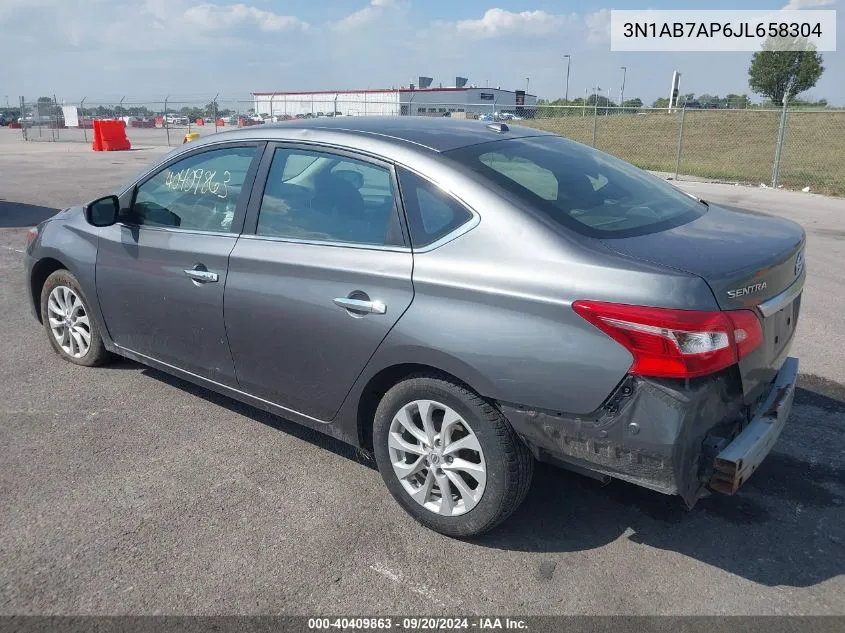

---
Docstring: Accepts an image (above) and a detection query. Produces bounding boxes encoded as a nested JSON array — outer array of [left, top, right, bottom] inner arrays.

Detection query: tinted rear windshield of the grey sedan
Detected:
[[447, 136, 707, 238]]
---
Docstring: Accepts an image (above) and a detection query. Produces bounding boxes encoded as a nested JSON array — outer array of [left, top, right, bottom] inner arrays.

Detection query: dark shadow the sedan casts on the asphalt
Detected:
[[122, 361, 845, 586]]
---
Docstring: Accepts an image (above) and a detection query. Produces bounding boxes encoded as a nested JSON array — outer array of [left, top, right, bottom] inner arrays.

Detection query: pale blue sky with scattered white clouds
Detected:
[[0, 0, 845, 106]]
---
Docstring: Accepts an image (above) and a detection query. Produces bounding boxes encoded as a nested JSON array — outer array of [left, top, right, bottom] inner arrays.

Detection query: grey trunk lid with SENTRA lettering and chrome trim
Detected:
[[602, 205, 805, 402]]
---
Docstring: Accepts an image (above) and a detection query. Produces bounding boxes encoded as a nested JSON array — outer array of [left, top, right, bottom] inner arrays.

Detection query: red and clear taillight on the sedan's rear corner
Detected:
[[572, 301, 763, 378]]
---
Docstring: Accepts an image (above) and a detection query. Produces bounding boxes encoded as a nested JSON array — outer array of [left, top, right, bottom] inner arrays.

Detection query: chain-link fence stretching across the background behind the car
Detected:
[[13, 94, 845, 195]]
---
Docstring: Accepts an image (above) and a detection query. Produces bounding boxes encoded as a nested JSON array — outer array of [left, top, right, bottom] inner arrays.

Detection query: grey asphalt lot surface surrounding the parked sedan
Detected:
[[0, 130, 845, 615]]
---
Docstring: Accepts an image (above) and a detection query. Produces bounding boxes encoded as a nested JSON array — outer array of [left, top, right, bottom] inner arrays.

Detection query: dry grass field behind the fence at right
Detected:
[[520, 108, 845, 196]]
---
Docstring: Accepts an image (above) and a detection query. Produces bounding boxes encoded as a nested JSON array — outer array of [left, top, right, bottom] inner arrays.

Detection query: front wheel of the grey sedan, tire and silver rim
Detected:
[[41, 270, 112, 367]]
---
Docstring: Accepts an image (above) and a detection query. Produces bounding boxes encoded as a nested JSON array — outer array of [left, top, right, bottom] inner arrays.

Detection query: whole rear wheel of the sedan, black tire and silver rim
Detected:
[[373, 374, 534, 538]]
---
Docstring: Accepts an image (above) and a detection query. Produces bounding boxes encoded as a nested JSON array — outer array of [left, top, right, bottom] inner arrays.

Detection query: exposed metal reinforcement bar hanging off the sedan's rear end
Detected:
[[709, 358, 798, 494]]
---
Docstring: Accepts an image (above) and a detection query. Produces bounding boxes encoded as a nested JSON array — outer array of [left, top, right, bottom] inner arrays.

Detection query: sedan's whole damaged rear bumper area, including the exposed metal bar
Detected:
[[499, 358, 798, 507]]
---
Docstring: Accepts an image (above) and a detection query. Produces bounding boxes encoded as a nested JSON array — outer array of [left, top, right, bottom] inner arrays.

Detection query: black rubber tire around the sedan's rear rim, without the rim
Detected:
[[373, 378, 510, 536]]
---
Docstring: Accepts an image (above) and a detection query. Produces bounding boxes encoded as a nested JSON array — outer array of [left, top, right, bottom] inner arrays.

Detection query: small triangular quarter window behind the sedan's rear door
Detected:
[[398, 169, 472, 248]]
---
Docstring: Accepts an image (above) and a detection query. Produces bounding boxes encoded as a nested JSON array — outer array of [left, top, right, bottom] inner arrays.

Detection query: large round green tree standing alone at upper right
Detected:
[[748, 38, 824, 105]]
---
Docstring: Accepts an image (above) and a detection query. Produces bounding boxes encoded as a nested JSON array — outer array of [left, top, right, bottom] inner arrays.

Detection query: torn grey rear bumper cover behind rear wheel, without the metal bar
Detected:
[[501, 369, 743, 506]]
